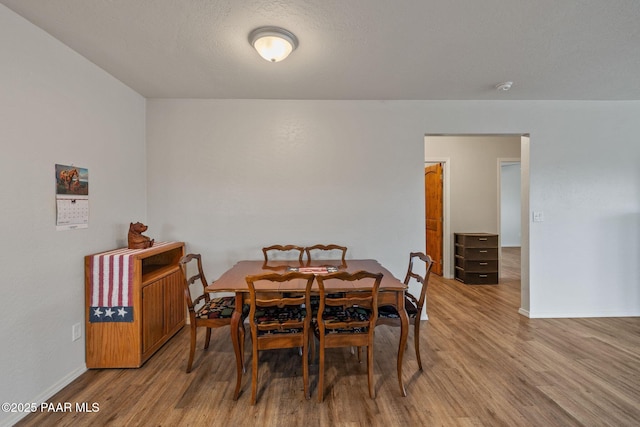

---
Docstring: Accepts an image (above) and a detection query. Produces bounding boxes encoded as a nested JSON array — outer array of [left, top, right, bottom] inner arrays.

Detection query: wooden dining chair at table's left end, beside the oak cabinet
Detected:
[[179, 254, 249, 373]]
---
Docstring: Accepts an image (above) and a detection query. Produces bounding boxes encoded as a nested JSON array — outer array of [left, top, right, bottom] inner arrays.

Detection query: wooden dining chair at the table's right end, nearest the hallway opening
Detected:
[[377, 252, 433, 370]]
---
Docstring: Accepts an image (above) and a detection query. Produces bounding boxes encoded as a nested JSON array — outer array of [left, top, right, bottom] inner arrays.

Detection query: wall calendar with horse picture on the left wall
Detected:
[[55, 165, 89, 230]]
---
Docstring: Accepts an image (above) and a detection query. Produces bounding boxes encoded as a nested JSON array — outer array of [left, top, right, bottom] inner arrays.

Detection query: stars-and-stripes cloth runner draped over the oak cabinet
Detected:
[[89, 242, 171, 323]]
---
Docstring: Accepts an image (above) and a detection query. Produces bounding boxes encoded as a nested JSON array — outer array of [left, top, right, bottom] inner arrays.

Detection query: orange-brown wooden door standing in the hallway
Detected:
[[424, 163, 443, 276]]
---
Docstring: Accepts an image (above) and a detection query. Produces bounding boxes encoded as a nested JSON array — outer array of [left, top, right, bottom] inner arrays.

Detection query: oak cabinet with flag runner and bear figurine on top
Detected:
[[85, 242, 186, 368]]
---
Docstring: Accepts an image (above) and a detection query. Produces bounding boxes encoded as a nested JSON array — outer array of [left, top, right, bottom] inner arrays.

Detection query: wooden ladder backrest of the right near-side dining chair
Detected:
[[316, 271, 383, 335]]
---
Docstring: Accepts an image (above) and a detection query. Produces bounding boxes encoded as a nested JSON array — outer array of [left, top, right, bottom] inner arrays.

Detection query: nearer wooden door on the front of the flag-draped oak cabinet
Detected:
[[142, 279, 164, 353]]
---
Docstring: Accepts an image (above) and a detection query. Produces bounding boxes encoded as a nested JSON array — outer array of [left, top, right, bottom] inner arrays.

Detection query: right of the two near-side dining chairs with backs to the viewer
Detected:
[[313, 271, 382, 402]]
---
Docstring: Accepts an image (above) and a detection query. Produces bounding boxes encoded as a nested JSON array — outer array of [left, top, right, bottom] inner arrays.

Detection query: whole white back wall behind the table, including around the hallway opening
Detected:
[[147, 100, 640, 317]]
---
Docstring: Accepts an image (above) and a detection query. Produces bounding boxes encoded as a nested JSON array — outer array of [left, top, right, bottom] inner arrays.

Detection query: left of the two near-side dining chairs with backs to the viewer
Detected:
[[246, 272, 315, 405]]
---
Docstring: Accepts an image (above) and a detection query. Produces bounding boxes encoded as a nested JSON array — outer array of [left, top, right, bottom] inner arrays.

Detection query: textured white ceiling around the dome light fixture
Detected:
[[0, 0, 640, 100]]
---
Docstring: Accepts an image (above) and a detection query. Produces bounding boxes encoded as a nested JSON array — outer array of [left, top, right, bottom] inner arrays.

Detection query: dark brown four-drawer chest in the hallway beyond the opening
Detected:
[[454, 233, 498, 285]]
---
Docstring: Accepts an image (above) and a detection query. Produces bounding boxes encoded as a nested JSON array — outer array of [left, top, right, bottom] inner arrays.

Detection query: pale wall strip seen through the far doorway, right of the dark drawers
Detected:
[[500, 164, 522, 247]]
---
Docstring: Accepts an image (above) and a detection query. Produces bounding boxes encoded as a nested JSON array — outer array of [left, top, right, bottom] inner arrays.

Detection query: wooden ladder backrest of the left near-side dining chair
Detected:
[[246, 272, 315, 336]]
